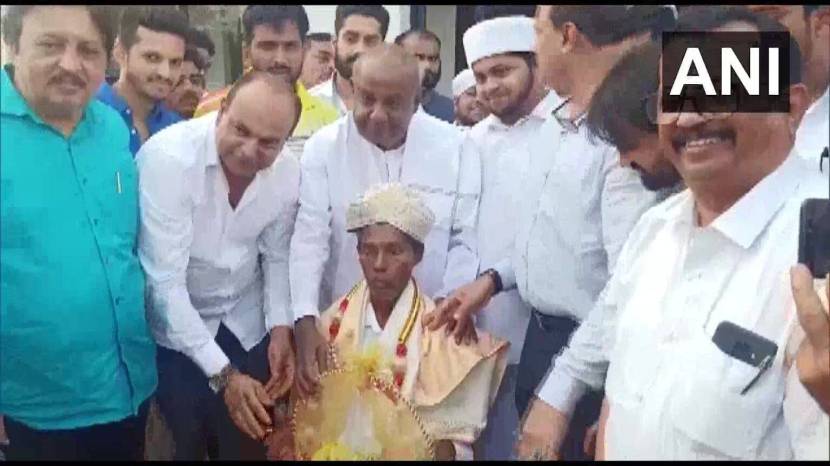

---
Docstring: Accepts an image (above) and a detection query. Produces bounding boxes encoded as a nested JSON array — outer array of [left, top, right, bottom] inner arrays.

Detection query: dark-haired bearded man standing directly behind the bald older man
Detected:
[[308, 4, 389, 116]]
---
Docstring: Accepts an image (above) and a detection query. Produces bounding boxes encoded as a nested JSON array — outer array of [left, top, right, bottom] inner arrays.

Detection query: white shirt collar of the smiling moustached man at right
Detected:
[[681, 151, 804, 249]]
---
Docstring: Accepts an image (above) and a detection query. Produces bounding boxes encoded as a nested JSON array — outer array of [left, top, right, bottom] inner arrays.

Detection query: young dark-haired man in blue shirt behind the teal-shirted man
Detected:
[[98, 6, 190, 156]]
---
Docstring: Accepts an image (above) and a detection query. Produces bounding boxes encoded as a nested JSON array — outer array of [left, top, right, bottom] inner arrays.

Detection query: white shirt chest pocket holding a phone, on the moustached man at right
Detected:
[[669, 336, 786, 459]]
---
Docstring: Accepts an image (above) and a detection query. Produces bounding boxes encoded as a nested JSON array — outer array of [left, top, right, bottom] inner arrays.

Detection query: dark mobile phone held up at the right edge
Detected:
[[798, 199, 830, 278]]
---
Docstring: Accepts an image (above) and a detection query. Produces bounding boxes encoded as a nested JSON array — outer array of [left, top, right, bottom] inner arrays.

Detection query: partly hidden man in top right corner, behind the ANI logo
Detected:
[[748, 5, 830, 164]]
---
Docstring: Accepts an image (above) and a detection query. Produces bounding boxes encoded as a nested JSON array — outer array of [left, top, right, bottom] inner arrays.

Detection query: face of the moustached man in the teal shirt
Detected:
[[11, 6, 107, 119]]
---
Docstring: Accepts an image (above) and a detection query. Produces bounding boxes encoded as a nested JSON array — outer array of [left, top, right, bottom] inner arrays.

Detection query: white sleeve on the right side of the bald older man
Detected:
[[435, 141, 481, 298]]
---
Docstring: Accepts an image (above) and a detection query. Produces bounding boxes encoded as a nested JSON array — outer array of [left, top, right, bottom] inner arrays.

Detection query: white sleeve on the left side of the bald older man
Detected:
[[289, 133, 331, 321]]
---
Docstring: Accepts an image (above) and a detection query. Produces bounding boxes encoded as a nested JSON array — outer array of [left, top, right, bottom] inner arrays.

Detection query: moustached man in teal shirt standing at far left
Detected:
[[0, 5, 157, 460]]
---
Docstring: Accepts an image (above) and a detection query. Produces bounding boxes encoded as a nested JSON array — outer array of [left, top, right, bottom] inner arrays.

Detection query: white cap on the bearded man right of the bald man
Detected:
[[464, 16, 536, 67]]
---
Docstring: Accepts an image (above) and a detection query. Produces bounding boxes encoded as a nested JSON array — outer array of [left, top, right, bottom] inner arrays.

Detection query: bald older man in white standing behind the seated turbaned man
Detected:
[[291, 45, 481, 400]]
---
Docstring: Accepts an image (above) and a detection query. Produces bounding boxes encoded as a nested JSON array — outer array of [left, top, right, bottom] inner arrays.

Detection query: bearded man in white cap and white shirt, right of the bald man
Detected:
[[464, 16, 559, 460]]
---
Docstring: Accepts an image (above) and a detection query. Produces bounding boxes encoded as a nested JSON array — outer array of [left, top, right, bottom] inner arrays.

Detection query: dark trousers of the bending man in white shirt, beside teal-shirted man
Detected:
[[156, 325, 270, 461]]
